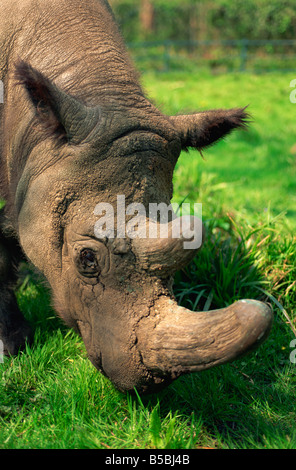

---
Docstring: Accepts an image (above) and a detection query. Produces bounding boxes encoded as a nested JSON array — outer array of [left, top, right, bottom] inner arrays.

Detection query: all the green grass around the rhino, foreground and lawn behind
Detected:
[[0, 72, 296, 449]]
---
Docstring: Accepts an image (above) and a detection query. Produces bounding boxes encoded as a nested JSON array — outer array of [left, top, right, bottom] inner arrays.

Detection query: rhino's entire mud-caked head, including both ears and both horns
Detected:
[[13, 63, 272, 392]]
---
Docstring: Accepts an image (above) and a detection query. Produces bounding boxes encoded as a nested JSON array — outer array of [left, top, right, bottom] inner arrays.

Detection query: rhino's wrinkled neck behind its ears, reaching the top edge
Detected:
[[4, 0, 142, 106]]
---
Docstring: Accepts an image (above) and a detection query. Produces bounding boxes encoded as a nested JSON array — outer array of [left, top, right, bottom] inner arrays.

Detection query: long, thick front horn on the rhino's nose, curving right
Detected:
[[136, 296, 273, 378]]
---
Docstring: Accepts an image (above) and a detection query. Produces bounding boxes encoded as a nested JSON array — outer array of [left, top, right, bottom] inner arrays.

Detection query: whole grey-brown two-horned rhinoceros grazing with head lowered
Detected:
[[0, 0, 272, 393]]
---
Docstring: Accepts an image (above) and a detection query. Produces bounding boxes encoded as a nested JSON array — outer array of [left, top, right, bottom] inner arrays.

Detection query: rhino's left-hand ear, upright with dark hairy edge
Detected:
[[15, 61, 100, 144]]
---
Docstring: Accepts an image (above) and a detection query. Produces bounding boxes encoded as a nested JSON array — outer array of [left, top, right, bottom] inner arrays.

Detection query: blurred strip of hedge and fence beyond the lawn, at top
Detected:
[[111, 0, 296, 73]]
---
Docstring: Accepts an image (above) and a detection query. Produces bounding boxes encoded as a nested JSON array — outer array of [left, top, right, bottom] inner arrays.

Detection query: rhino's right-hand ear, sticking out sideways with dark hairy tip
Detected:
[[171, 108, 249, 150]]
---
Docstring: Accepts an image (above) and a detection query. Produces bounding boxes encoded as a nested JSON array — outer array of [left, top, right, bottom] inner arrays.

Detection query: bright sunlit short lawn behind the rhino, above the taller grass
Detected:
[[144, 72, 296, 228]]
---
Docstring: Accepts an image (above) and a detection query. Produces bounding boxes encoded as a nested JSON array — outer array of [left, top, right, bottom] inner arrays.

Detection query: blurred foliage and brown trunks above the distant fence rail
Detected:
[[110, 0, 296, 42]]
